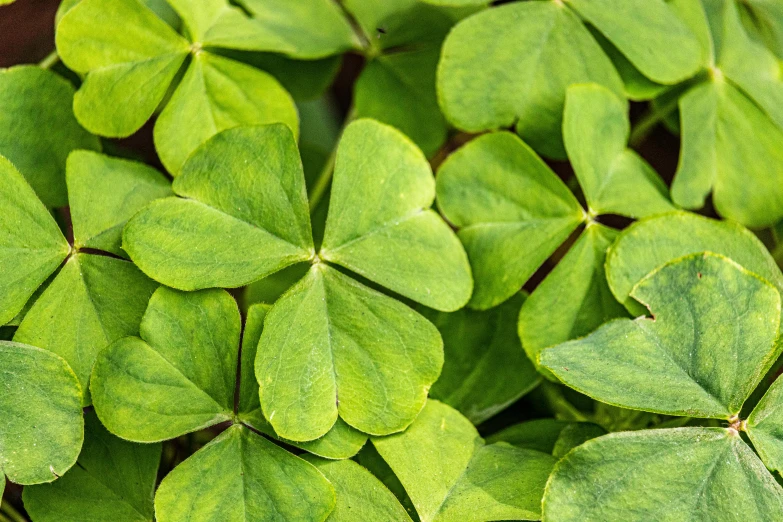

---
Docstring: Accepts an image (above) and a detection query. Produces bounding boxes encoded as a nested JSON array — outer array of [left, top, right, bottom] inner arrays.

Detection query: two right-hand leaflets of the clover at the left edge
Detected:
[[14, 151, 171, 406]]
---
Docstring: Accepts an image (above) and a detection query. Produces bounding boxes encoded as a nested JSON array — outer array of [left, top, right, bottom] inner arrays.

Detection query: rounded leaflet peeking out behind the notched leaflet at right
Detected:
[[606, 212, 783, 315]]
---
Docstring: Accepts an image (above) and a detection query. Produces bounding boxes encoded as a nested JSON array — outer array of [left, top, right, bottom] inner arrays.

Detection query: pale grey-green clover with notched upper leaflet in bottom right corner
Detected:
[[540, 252, 783, 521]]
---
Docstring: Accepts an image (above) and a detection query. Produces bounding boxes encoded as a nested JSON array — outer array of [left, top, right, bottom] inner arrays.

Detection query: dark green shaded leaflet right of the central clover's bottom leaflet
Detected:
[[422, 294, 540, 424]]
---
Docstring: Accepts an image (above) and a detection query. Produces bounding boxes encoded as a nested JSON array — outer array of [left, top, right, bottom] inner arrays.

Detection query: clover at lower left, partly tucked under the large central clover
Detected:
[[91, 287, 334, 520]]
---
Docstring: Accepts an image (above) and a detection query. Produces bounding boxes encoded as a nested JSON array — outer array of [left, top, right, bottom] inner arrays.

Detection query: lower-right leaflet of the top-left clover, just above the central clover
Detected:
[[154, 51, 299, 176]]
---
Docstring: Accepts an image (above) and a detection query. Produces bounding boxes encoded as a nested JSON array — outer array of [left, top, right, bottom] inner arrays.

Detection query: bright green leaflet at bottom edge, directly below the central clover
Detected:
[[307, 458, 411, 522]]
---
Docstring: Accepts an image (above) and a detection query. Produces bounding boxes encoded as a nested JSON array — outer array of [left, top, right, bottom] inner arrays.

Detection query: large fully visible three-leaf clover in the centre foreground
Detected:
[[123, 120, 472, 442]]
